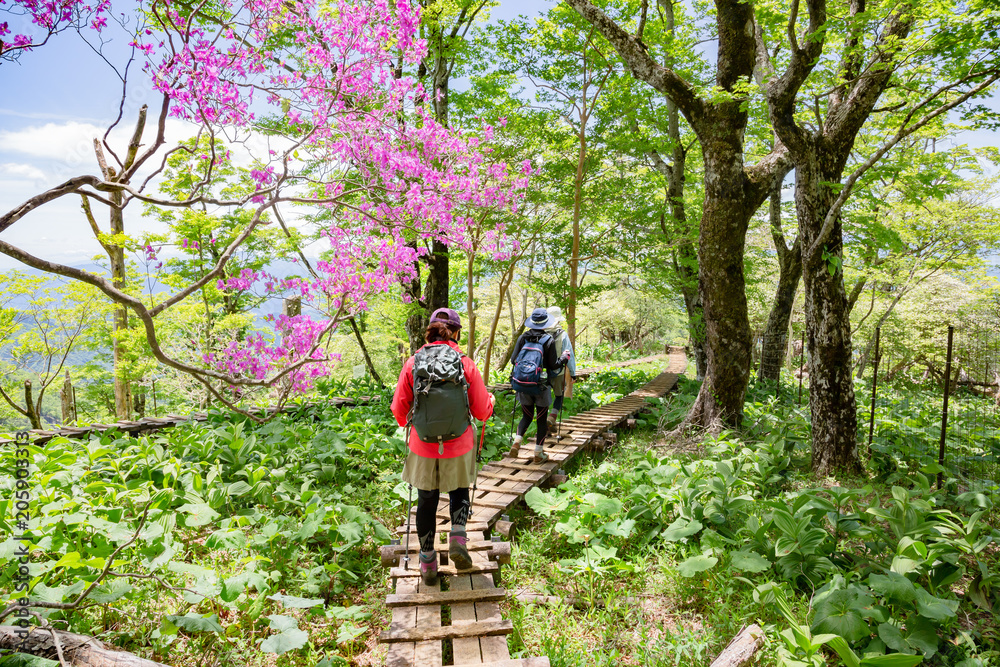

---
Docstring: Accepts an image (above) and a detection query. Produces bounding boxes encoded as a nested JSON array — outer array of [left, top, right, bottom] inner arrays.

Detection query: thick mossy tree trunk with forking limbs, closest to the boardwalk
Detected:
[[564, 0, 790, 428]]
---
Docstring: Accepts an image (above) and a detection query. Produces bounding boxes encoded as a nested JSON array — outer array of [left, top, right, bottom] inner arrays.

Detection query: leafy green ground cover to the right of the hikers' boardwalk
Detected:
[[507, 379, 1000, 667]]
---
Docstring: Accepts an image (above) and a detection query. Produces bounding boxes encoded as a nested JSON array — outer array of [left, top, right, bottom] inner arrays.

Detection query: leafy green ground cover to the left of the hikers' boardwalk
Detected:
[[0, 370, 647, 665]]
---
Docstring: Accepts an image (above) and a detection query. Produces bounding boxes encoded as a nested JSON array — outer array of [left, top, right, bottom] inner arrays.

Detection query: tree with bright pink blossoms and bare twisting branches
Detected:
[[0, 0, 527, 418]]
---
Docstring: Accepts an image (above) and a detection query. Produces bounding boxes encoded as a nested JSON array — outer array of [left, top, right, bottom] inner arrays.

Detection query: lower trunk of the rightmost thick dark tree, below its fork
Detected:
[[795, 159, 861, 475]]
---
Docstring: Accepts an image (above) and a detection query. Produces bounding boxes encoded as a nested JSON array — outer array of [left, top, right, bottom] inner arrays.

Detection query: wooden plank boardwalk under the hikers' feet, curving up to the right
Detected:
[[379, 352, 686, 667]]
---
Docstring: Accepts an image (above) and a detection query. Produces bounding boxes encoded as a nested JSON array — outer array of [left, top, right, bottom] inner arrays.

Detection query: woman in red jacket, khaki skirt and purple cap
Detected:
[[392, 308, 494, 586]]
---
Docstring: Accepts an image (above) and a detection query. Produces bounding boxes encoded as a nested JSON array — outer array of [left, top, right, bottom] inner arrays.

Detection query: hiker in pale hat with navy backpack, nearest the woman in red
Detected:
[[507, 308, 570, 463]]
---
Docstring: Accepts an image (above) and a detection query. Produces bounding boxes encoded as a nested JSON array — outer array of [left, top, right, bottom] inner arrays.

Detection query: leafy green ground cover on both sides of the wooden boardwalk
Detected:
[[0, 365, 1000, 667]]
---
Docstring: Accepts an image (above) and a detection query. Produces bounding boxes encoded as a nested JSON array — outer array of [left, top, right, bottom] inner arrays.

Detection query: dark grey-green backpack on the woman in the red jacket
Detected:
[[411, 345, 472, 454]]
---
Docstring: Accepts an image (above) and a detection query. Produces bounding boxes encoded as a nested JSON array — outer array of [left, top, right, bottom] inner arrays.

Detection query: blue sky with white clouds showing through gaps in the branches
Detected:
[[0, 0, 996, 270]]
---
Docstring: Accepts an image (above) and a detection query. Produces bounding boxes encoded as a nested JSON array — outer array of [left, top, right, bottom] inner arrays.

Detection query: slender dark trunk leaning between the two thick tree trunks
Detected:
[[760, 184, 802, 382]]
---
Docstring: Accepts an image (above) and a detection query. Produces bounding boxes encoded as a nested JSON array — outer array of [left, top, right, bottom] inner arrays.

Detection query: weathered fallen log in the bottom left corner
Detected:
[[0, 625, 168, 667]]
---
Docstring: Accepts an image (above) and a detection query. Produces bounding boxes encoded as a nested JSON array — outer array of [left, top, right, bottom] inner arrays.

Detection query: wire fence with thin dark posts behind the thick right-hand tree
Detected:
[[751, 321, 1000, 497]]
